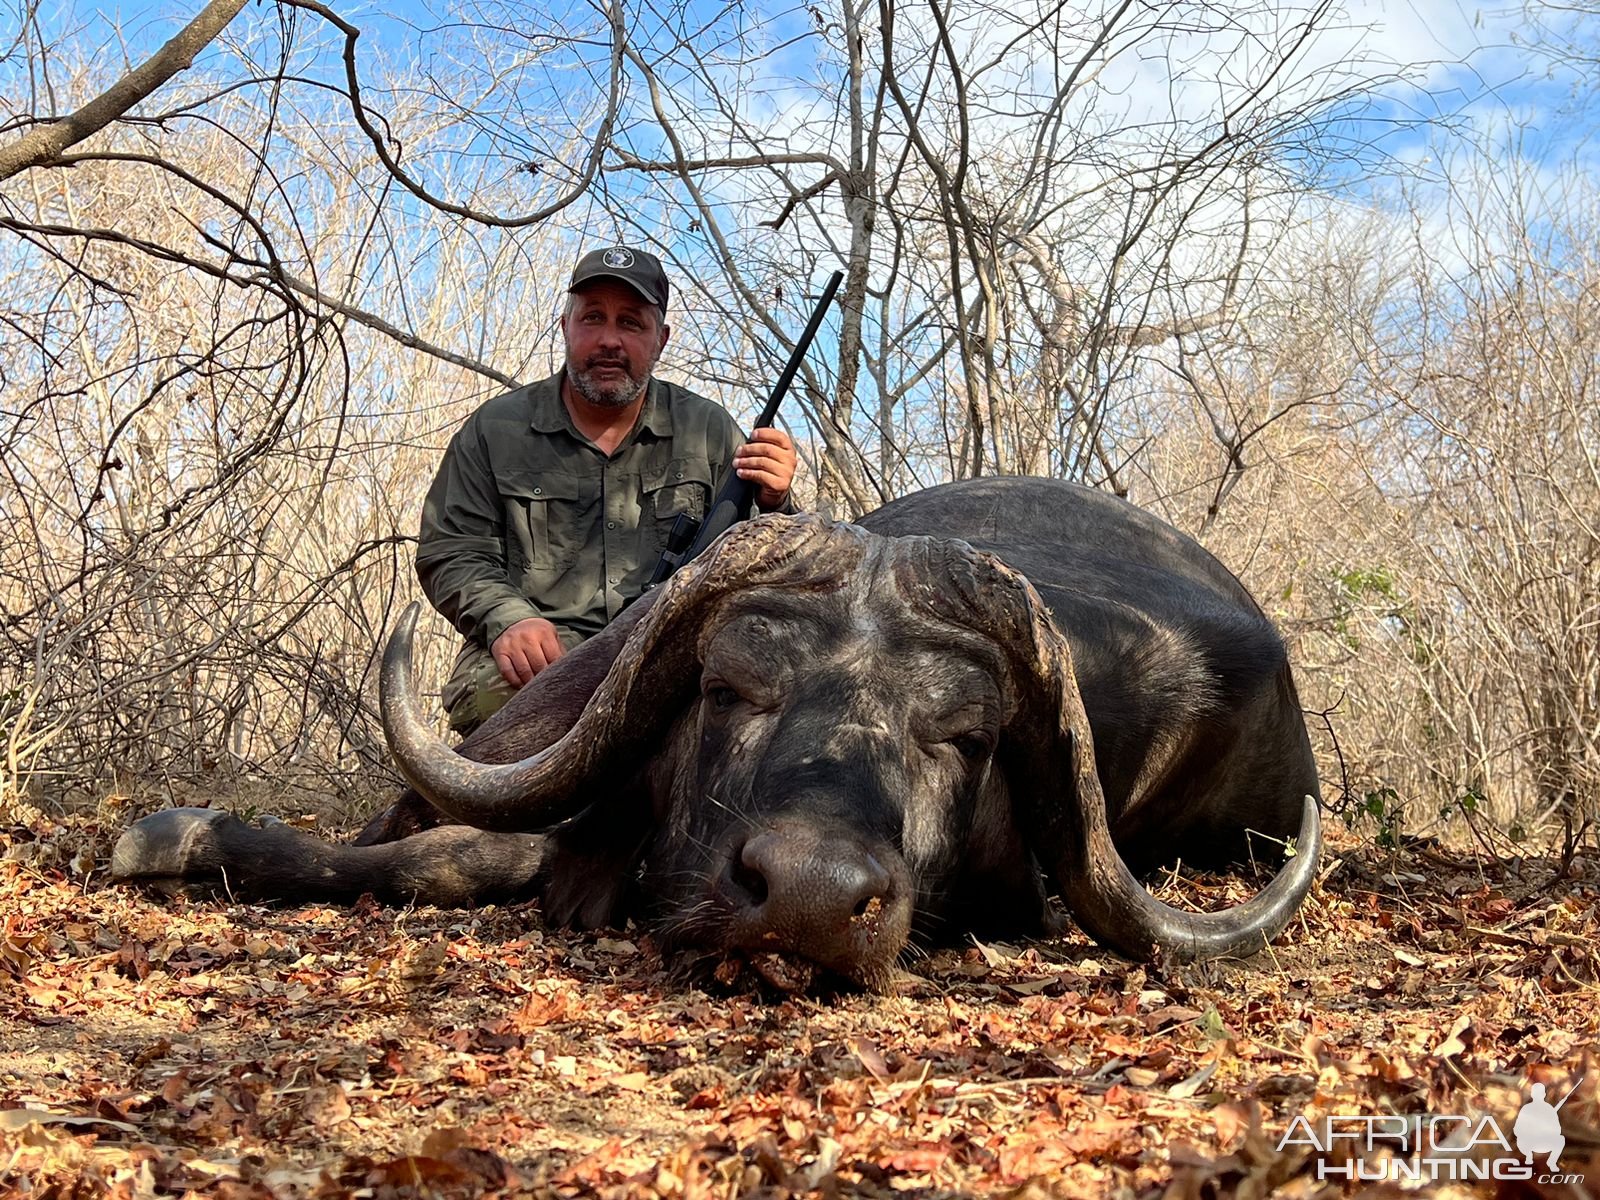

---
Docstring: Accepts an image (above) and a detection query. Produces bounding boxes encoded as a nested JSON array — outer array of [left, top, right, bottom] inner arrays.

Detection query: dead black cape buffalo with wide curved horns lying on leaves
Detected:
[[112, 478, 1320, 987]]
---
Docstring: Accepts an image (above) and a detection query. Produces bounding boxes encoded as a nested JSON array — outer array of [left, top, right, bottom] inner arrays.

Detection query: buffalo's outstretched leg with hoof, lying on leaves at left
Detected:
[[110, 808, 544, 907]]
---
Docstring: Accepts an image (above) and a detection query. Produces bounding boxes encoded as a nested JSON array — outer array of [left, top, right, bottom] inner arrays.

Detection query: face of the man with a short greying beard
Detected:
[[562, 280, 669, 408]]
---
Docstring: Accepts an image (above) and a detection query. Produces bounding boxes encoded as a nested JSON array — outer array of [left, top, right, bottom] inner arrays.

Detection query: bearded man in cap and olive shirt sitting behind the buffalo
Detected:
[[416, 246, 797, 734]]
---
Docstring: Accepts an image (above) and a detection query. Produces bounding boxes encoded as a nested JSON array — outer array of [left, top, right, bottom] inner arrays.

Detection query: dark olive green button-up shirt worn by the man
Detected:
[[416, 374, 758, 646]]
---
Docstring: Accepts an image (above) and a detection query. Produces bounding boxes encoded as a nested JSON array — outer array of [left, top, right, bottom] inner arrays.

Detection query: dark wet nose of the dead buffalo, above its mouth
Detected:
[[730, 827, 893, 949]]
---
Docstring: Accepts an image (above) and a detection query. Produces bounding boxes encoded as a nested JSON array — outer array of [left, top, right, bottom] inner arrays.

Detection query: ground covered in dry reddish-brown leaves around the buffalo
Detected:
[[0, 803, 1600, 1200]]
